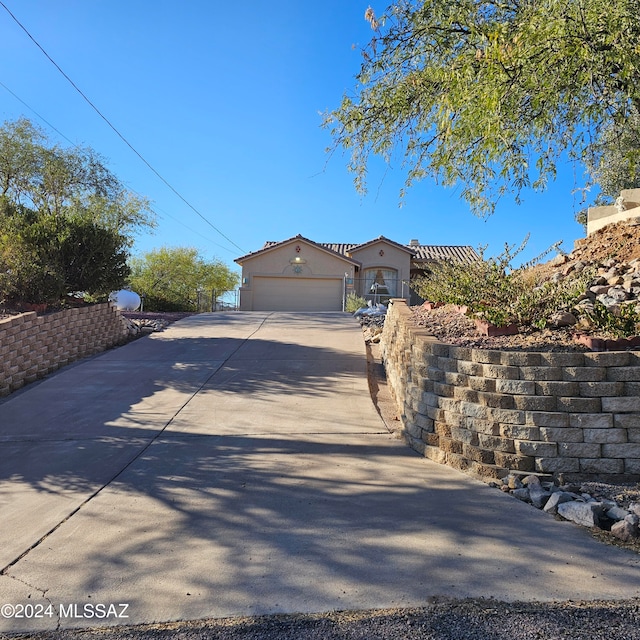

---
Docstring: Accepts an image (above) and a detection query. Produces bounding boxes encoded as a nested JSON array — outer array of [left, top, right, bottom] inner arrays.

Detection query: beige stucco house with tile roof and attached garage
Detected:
[[235, 235, 478, 311]]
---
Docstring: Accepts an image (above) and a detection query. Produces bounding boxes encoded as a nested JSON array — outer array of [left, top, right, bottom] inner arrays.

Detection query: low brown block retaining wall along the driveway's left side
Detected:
[[0, 303, 128, 396]]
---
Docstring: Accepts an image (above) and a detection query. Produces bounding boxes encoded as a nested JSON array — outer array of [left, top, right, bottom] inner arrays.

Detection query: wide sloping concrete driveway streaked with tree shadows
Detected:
[[0, 312, 640, 631]]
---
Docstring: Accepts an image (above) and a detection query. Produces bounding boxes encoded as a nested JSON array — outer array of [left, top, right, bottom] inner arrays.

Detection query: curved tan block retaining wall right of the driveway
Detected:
[[381, 299, 640, 482]]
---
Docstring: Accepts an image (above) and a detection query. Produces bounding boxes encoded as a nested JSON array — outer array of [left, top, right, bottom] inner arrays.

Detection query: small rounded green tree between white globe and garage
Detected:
[[129, 247, 238, 311]]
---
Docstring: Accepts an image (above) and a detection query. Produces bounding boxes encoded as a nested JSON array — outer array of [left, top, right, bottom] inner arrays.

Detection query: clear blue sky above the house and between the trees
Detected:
[[0, 0, 584, 278]]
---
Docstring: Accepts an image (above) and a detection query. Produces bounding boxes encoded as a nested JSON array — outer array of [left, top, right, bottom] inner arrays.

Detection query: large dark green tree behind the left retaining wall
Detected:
[[0, 118, 154, 303]]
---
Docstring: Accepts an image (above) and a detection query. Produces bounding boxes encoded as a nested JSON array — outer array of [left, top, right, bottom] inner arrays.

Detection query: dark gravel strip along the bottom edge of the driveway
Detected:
[[7, 599, 640, 640]]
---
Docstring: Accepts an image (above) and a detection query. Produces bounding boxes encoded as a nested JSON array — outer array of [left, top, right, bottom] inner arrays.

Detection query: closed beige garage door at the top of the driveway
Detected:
[[253, 276, 343, 311]]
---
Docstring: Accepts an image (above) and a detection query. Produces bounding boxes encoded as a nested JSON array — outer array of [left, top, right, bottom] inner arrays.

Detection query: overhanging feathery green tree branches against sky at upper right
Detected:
[[324, 0, 640, 214]]
